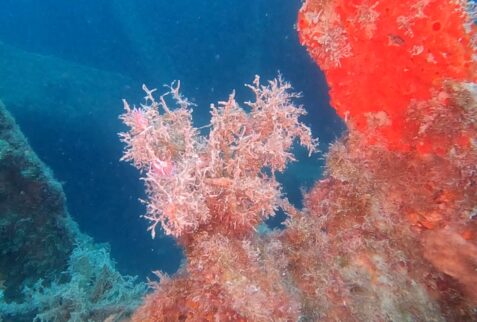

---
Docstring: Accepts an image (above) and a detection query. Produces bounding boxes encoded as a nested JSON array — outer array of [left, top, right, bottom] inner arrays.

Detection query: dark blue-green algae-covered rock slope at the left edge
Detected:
[[0, 102, 74, 301]]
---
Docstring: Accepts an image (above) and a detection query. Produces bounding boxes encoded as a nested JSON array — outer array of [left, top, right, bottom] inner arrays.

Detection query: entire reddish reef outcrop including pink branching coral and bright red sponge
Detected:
[[121, 0, 477, 321]]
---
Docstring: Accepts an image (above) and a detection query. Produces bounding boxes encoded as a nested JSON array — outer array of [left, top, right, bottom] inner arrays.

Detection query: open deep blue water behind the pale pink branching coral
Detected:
[[0, 0, 343, 277]]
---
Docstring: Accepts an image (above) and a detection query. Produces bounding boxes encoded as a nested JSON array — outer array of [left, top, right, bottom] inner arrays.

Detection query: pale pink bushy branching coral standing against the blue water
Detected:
[[121, 76, 316, 237]]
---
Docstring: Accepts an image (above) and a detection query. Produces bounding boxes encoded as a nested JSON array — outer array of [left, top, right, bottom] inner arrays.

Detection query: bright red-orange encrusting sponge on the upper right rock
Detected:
[[297, 0, 477, 152]]
